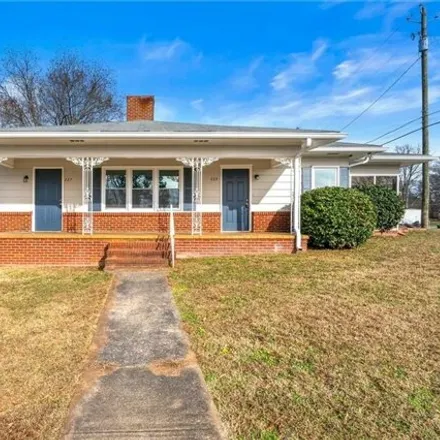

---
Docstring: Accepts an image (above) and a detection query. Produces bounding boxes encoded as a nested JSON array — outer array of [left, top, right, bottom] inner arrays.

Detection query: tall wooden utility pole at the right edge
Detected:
[[419, 5, 430, 228]]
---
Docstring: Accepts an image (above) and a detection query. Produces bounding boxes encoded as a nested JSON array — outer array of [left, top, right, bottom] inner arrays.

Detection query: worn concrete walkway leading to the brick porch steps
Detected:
[[65, 272, 222, 440]]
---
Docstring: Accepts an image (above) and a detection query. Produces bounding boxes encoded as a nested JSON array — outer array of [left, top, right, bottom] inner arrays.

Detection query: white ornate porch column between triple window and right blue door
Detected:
[[176, 157, 218, 235]]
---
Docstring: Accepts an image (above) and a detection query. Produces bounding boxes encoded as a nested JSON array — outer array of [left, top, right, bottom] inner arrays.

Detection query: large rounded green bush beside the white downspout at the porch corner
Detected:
[[301, 187, 376, 249]]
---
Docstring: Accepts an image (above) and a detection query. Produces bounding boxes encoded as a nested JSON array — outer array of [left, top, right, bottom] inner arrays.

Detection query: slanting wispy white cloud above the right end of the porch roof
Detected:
[[271, 39, 328, 91]]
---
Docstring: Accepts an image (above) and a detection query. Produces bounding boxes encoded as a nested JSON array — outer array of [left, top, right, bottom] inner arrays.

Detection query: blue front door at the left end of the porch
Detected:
[[35, 168, 63, 231]]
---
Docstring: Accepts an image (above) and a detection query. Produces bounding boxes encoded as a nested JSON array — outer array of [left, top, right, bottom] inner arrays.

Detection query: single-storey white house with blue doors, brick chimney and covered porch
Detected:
[[0, 96, 435, 262]]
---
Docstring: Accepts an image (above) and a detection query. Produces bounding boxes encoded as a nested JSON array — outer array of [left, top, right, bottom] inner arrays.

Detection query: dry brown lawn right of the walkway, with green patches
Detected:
[[171, 231, 440, 440]]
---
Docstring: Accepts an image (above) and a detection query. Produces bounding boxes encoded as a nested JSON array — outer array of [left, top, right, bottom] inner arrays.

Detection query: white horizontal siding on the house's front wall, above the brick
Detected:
[[0, 158, 358, 212]]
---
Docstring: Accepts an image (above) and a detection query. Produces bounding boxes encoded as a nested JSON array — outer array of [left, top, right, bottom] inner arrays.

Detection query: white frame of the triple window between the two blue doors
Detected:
[[101, 165, 183, 212]]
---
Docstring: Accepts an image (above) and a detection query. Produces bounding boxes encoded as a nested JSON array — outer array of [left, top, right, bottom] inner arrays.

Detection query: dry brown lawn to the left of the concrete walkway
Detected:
[[0, 268, 110, 440]]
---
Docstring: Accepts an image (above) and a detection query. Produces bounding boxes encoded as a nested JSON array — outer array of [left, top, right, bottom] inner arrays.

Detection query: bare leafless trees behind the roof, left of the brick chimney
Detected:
[[0, 52, 122, 127]]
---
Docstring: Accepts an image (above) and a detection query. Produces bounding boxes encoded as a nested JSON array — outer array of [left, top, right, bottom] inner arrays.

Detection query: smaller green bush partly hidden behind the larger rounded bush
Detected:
[[358, 185, 405, 232]]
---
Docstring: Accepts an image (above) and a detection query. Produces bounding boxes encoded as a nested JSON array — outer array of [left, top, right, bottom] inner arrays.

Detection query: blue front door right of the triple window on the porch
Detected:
[[222, 169, 249, 232]]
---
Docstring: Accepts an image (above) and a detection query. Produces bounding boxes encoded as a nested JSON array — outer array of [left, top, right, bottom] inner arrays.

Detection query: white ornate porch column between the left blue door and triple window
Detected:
[[67, 157, 108, 234]]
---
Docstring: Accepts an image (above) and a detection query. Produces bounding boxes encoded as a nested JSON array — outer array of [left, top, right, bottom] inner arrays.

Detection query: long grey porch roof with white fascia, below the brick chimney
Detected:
[[0, 121, 345, 159]]
